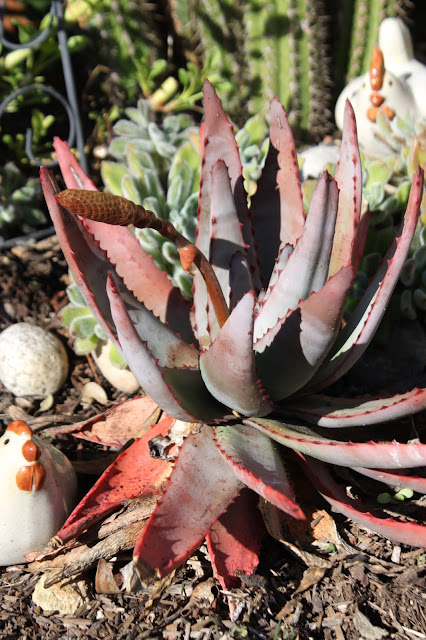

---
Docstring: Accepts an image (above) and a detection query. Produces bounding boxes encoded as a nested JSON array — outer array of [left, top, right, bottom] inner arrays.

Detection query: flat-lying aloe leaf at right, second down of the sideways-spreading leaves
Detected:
[[244, 418, 426, 469]]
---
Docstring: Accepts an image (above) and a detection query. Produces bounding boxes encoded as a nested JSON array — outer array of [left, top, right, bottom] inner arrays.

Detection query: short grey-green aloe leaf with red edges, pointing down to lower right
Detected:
[[214, 424, 305, 520]]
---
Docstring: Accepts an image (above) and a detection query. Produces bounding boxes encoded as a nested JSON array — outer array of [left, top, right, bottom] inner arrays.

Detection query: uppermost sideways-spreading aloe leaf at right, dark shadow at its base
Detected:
[[285, 388, 426, 428]]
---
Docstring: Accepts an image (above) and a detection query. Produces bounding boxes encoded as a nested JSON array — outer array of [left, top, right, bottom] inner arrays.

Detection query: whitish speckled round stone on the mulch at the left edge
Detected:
[[0, 322, 68, 396]]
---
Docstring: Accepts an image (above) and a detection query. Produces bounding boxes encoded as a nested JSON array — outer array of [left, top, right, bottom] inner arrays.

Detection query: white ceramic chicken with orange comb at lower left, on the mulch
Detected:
[[0, 420, 76, 566]]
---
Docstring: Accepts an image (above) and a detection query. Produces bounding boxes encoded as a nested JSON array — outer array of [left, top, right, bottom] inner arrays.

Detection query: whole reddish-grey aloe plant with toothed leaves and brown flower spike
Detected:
[[41, 82, 426, 586]]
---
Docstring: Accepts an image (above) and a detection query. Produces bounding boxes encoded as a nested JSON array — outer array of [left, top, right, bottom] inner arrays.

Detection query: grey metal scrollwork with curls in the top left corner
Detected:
[[0, 0, 87, 171]]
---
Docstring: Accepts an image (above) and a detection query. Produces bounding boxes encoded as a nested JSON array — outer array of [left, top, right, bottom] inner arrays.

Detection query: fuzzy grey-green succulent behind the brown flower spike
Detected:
[[101, 100, 200, 297]]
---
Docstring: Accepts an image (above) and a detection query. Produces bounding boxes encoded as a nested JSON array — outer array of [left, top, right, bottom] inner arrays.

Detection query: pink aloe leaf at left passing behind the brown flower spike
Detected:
[[53, 138, 194, 342]]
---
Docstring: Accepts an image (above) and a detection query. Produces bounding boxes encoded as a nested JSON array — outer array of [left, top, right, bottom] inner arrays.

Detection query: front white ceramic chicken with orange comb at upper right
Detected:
[[335, 47, 417, 158]]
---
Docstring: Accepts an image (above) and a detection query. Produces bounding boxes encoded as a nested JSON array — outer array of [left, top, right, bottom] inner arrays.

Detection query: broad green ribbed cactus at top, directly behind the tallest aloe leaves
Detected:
[[170, 0, 332, 135]]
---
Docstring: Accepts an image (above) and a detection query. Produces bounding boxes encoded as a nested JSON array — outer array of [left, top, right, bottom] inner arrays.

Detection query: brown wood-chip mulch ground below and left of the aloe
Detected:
[[0, 236, 426, 640]]
